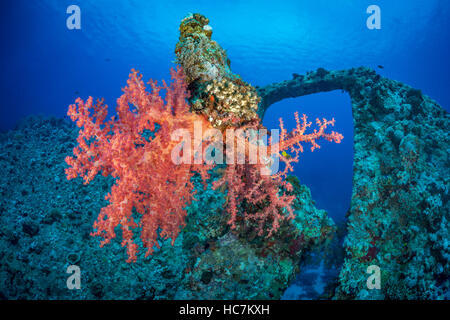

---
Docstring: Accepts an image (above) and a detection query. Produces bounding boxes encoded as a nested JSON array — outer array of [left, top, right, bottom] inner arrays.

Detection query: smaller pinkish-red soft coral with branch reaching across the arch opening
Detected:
[[214, 112, 343, 237]]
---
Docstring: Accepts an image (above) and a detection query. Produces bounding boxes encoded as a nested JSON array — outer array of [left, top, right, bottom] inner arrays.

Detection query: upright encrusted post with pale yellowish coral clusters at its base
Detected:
[[175, 13, 260, 129]]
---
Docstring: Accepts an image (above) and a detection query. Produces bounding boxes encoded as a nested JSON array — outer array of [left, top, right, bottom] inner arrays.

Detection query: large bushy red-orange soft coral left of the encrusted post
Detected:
[[66, 69, 214, 262]]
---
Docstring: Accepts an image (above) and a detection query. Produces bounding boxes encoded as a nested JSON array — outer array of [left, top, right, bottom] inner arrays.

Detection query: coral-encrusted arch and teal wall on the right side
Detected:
[[258, 67, 450, 299]]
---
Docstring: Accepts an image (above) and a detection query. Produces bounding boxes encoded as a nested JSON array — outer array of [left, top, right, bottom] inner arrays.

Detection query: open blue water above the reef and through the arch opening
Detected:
[[0, 0, 450, 219]]
